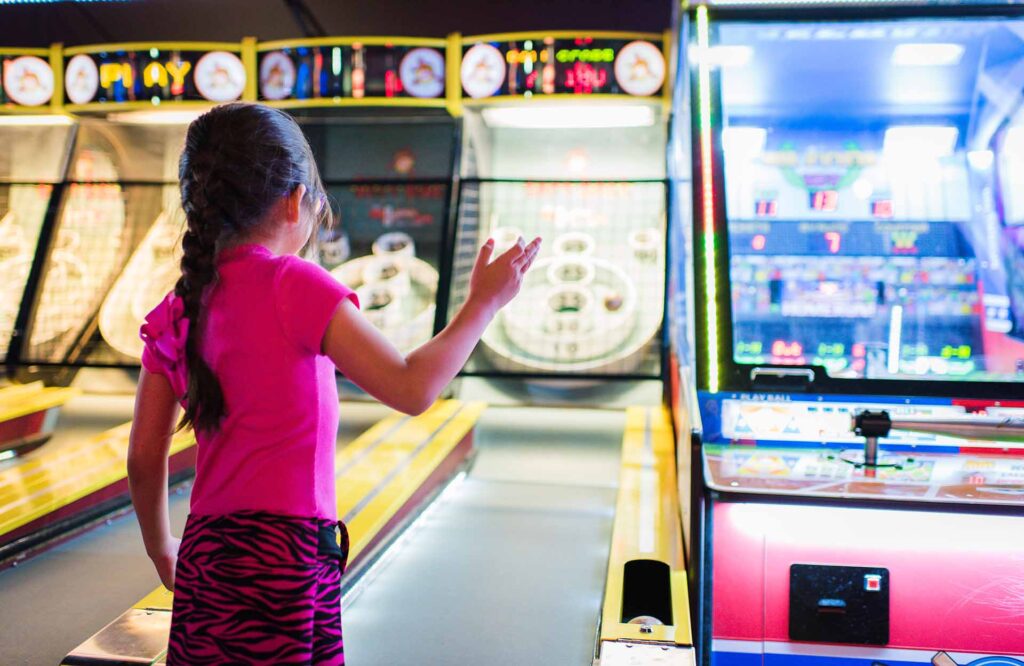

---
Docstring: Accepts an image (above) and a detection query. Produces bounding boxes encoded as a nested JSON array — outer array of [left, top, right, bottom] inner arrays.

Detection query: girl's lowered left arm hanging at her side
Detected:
[[128, 368, 179, 590]]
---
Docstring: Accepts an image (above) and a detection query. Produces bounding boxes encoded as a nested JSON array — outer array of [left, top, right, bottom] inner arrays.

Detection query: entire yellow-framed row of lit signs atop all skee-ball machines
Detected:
[[0, 33, 667, 113]]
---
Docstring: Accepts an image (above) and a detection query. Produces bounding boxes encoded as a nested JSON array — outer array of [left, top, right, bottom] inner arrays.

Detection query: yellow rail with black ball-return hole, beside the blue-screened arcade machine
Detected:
[[600, 407, 693, 666]]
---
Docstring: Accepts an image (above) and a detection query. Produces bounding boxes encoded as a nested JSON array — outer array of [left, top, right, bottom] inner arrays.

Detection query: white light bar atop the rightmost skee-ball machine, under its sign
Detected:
[[483, 105, 654, 129]]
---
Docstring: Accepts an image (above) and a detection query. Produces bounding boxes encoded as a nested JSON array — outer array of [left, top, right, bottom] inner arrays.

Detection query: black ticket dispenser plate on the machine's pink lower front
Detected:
[[790, 565, 889, 646]]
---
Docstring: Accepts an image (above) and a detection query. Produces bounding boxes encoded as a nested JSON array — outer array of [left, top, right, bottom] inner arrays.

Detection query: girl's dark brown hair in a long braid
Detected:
[[174, 99, 330, 430]]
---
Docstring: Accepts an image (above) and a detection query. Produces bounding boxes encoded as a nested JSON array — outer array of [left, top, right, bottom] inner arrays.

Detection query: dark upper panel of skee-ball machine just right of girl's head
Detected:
[[298, 116, 455, 181]]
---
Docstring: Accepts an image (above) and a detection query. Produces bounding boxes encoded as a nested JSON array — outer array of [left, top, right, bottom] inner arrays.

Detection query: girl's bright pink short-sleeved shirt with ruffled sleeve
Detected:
[[142, 245, 358, 521]]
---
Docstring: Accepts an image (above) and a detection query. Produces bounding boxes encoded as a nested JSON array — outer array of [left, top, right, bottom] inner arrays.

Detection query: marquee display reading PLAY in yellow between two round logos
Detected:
[[65, 46, 247, 106]]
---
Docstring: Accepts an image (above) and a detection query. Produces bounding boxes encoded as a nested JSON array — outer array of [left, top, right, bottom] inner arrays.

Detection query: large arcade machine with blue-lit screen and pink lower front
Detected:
[[688, 2, 1024, 666]]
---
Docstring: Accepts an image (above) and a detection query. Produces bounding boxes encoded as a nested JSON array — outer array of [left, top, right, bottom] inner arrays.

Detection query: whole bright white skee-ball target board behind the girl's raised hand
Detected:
[[449, 105, 667, 376]]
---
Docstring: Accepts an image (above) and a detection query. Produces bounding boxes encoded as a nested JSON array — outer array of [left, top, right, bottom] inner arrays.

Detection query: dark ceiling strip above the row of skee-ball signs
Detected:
[[0, 0, 673, 46]]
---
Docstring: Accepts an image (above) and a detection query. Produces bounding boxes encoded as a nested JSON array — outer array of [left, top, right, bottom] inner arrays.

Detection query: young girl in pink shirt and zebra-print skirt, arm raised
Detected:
[[128, 103, 540, 664]]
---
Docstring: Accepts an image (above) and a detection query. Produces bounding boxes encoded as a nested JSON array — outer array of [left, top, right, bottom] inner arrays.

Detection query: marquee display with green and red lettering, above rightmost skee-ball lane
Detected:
[[461, 35, 666, 98]]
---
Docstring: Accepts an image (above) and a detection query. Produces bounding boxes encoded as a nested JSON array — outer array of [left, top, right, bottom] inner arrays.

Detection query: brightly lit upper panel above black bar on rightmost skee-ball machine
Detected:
[[462, 105, 668, 180]]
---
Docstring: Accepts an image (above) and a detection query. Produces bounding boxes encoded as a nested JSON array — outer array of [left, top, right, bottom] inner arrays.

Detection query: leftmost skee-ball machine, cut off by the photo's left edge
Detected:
[[0, 48, 75, 450]]
